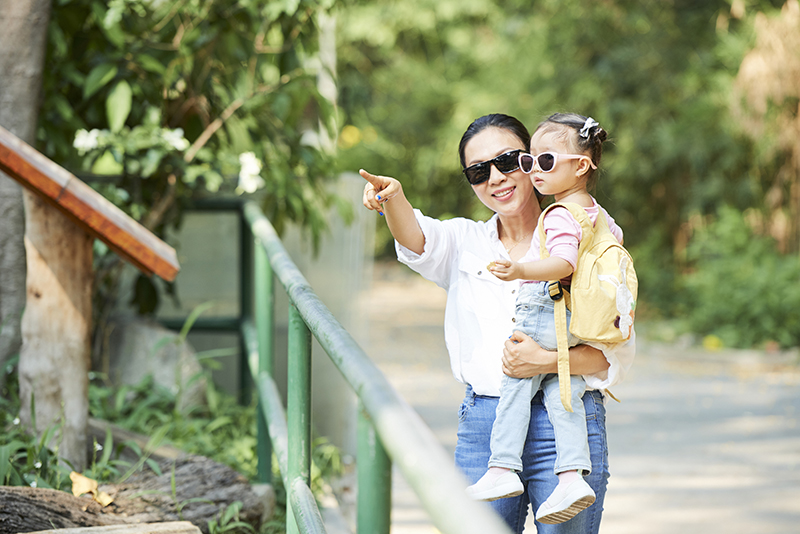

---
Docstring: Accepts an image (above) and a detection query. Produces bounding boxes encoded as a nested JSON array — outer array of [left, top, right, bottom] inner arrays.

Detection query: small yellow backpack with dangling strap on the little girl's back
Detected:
[[538, 202, 639, 412]]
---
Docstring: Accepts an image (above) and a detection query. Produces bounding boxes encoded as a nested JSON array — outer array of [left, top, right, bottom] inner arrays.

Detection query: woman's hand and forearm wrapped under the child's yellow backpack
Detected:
[[503, 331, 610, 378]]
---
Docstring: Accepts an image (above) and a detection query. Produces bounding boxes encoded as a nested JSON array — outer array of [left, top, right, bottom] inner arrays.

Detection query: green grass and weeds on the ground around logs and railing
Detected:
[[0, 352, 342, 534]]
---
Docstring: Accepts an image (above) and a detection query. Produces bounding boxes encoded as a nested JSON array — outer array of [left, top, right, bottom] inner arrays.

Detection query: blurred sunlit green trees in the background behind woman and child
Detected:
[[338, 0, 800, 352]]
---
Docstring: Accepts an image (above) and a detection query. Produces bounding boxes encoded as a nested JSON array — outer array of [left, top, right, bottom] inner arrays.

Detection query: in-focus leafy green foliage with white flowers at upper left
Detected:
[[38, 0, 334, 245]]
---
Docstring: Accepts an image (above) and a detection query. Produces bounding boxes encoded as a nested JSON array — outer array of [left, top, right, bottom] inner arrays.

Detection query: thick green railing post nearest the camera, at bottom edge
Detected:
[[356, 401, 392, 534]]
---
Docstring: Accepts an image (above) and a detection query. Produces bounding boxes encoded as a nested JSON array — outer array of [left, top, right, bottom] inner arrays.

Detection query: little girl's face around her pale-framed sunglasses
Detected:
[[530, 130, 589, 201]]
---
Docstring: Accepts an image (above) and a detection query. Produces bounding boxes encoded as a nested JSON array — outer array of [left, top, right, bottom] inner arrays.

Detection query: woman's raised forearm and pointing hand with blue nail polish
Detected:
[[358, 169, 425, 255]]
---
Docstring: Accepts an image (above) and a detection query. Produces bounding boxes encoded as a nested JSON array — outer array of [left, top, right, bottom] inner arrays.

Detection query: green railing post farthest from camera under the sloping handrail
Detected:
[[254, 240, 275, 483]]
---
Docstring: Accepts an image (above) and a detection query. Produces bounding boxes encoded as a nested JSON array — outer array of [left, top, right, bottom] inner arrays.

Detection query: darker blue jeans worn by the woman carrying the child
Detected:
[[455, 386, 610, 534]]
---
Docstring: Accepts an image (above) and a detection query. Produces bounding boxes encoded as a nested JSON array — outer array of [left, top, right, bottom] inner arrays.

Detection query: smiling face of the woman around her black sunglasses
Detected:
[[464, 126, 536, 216]]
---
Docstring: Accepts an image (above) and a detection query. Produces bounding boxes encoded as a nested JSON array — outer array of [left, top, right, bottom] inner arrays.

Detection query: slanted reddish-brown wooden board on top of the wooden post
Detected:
[[0, 126, 180, 281]]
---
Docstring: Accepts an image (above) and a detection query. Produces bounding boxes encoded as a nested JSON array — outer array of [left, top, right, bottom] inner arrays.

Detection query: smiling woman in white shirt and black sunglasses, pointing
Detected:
[[360, 114, 635, 534]]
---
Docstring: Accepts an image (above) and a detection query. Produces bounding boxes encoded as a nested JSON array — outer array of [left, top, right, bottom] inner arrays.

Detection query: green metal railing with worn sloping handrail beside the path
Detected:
[[171, 202, 510, 534]]
